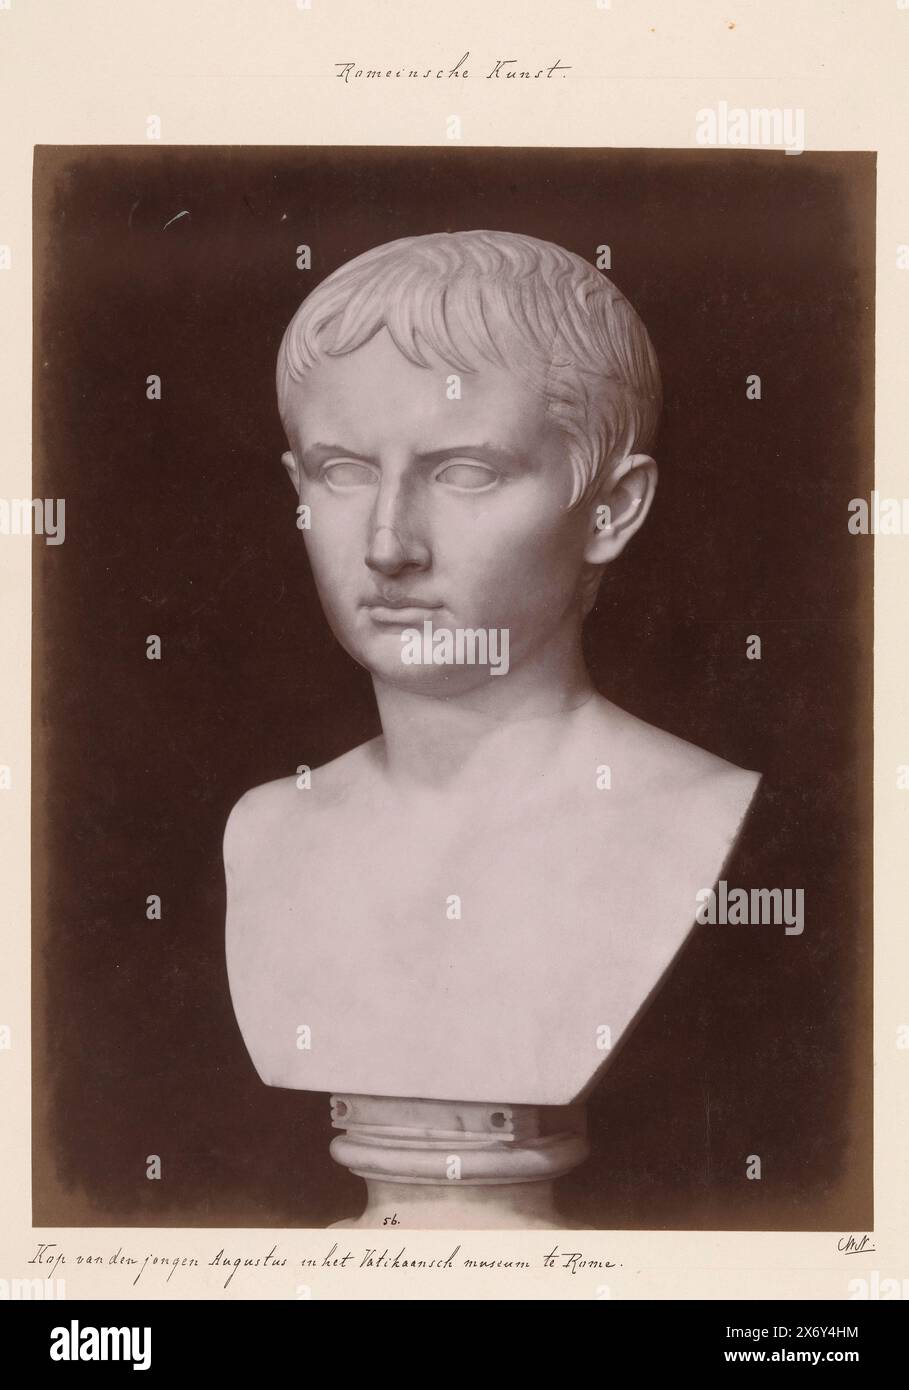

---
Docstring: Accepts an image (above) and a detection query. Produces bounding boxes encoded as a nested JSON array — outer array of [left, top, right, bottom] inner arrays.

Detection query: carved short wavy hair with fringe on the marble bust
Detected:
[[277, 231, 662, 506]]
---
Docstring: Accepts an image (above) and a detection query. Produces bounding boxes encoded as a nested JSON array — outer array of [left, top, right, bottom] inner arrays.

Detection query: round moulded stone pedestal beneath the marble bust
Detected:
[[331, 1094, 589, 1230]]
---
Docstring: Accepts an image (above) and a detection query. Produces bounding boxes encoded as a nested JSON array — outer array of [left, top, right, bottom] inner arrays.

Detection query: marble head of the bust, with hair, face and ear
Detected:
[[277, 231, 660, 694]]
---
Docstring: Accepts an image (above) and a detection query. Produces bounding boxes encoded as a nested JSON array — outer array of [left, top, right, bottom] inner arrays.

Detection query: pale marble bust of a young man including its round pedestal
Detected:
[[224, 231, 759, 1225]]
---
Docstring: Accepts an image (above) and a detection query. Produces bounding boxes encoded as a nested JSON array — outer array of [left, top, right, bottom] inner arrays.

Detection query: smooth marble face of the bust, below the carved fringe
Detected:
[[285, 329, 619, 694]]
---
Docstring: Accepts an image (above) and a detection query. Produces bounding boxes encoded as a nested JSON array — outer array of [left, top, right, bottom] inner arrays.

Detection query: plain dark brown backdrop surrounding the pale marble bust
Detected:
[[33, 147, 874, 1229]]
